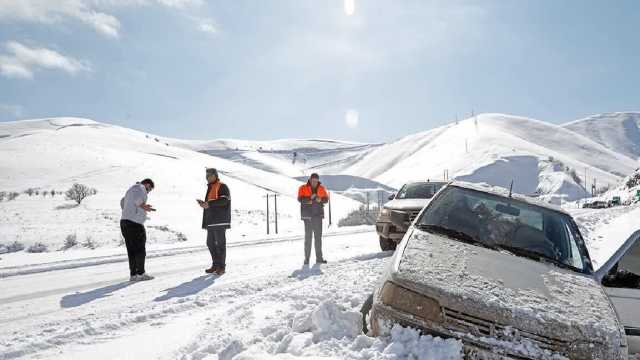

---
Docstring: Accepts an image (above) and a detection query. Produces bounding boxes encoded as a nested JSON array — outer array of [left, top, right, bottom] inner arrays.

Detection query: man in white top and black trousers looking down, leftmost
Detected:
[[120, 179, 156, 281]]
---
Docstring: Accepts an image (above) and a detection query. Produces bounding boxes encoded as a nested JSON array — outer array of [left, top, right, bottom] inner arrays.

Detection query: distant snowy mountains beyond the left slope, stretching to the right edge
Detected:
[[167, 113, 640, 201]]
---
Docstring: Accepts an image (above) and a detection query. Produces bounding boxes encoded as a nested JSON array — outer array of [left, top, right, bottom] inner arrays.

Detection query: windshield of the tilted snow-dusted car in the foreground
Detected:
[[416, 186, 586, 272]]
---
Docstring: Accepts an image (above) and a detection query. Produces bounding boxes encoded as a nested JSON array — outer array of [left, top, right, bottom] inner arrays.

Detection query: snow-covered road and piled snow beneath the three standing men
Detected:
[[0, 232, 458, 359]]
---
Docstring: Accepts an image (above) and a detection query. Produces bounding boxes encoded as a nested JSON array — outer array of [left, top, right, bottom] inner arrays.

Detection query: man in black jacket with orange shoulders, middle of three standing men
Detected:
[[198, 168, 231, 275]]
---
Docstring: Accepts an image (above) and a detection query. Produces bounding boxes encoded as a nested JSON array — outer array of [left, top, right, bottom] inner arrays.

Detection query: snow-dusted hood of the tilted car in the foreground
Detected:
[[391, 230, 621, 344]]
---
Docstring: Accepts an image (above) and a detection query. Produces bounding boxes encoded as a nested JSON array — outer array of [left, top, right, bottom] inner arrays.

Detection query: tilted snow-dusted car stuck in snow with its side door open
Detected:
[[363, 182, 640, 360]]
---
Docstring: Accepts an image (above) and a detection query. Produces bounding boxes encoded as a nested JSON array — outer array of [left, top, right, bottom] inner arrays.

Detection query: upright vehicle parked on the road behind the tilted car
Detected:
[[376, 181, 447, 251]]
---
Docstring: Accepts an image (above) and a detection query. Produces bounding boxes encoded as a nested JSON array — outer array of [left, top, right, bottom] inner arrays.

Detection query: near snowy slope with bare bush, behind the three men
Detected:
[[0, 118, 358, 256]]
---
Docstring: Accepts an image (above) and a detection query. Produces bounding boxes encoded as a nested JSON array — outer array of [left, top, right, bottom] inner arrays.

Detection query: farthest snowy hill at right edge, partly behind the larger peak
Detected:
[[563, 112, 640, 159]]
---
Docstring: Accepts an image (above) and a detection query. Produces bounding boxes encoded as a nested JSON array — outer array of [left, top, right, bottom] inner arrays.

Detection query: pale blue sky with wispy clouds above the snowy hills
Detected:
[[0, 0, 640, 142]]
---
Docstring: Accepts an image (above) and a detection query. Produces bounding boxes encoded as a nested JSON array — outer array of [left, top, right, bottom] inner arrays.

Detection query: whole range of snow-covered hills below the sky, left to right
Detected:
[[0, 113, 640, 255]]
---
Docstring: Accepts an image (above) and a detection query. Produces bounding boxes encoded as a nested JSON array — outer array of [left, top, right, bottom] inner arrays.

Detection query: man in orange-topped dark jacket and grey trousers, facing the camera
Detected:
[[298, 173, 329, 265]]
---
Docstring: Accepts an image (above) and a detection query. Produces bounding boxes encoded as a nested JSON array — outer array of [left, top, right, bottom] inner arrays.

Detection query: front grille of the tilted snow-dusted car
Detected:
[[443, 308, 569, 354]]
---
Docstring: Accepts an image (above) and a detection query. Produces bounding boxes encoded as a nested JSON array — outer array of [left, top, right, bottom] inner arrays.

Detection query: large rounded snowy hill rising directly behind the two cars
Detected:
[[332, 114, 636, 199]]
